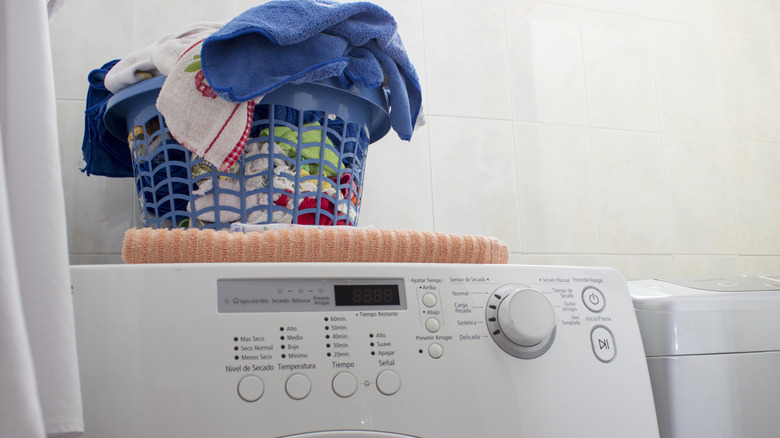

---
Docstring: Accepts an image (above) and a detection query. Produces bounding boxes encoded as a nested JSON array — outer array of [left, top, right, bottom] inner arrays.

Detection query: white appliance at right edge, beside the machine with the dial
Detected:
[[629, 275, 780, 438]]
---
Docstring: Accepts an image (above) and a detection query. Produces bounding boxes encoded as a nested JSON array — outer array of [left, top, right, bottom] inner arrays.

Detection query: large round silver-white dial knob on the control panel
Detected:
[[485, 284, 555, 359]]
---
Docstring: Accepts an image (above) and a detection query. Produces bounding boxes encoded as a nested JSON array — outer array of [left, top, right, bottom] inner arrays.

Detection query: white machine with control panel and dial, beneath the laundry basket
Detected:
[[71, 263, 658, 438]]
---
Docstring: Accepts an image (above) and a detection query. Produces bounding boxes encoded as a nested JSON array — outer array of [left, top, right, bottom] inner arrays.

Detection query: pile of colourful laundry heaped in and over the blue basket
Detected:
[[82, 0, 422, 228]]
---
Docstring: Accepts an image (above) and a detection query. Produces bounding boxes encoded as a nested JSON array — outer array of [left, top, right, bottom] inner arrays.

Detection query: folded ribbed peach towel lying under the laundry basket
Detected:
[[122, 227, 509, 264]]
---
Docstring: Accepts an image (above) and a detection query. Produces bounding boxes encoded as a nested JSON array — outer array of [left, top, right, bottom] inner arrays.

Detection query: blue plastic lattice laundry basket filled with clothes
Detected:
[[104, 76, 390, 229]]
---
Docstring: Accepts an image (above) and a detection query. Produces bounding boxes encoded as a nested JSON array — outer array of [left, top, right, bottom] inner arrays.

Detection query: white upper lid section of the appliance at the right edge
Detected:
[[628, 275, 780, 357]]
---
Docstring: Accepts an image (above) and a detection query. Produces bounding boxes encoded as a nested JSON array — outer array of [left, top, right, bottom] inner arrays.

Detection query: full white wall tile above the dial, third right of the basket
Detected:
[[515, 123, 600, 253]]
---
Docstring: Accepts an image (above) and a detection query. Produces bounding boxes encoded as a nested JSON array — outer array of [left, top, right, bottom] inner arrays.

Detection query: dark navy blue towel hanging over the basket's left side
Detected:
[[81, 59, 133, 178]]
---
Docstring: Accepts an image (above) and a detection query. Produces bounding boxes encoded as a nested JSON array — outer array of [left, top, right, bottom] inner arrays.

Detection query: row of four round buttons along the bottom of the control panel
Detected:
[[238, 370, 402, 403]]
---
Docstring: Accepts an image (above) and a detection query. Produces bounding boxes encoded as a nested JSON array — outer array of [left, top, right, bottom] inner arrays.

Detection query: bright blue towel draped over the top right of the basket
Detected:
[[201, 0, 422, 140]]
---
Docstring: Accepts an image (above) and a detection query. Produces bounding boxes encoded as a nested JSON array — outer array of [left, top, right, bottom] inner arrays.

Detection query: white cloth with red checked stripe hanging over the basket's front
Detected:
[[157, 41, 255, 172]]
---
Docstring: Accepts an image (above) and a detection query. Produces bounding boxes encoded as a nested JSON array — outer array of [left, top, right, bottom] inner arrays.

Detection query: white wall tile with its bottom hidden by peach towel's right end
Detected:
[[430, 117, 522, 252]]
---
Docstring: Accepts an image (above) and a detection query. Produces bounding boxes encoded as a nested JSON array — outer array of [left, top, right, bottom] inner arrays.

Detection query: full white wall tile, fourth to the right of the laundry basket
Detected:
[[591, 129, 672, 254]]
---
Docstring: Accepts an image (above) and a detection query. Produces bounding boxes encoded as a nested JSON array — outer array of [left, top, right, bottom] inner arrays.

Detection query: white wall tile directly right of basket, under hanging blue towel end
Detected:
[[359, 123, 433, 231]]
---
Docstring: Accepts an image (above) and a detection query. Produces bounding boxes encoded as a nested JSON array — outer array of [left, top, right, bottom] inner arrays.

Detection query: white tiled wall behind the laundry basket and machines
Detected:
[[51, 0, 780, 278]]
